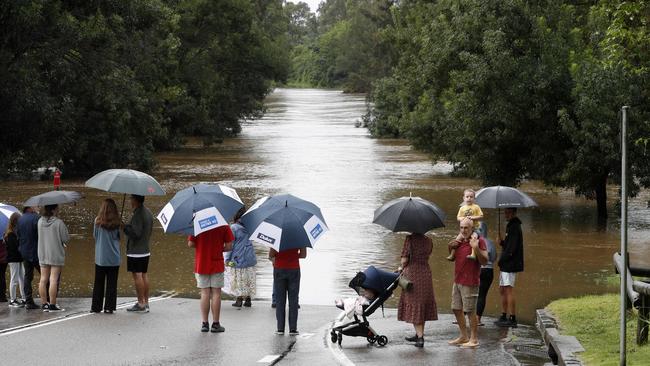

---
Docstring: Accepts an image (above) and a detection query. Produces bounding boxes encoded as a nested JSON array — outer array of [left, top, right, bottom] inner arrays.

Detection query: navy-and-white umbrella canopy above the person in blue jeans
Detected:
[[240, 194, 329, 252]]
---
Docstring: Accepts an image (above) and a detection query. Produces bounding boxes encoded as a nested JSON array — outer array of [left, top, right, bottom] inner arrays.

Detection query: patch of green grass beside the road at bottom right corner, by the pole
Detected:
[[548, 294, 650, 366]]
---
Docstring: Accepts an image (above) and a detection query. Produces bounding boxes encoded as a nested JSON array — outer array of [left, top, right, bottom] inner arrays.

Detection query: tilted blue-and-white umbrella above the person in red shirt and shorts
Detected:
[[157, 183, 244, 235]]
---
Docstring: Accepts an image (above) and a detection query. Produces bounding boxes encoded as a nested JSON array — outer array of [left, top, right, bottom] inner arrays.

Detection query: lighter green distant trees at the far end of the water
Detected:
[[285, 0, 395, 92]]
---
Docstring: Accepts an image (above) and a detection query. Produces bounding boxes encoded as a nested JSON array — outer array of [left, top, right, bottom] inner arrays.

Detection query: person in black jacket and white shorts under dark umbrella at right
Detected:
[[495, 208, 524, 328]]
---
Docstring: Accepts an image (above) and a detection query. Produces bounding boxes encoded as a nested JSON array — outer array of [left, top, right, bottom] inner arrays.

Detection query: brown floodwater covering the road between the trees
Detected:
[[0, 89, 650, 322]]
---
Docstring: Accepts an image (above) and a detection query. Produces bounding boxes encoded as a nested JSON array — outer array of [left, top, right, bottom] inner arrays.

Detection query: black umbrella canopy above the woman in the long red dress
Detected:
[[372, 197, 446, 234]]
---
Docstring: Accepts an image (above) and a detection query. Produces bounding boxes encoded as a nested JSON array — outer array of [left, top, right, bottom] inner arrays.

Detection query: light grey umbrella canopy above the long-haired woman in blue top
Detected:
[[86, 169, 165, 196]]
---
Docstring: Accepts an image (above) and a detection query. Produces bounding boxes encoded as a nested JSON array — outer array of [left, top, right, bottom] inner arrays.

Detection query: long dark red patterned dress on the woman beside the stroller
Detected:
[[397, 234, 438, 324]]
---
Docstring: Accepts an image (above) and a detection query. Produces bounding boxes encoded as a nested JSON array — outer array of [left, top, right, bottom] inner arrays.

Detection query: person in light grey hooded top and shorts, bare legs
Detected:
[[38, 204, 70, 312]]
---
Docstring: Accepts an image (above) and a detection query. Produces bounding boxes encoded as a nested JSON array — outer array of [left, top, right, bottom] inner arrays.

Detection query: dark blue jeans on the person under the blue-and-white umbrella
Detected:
[[273, 269, 300, 331]]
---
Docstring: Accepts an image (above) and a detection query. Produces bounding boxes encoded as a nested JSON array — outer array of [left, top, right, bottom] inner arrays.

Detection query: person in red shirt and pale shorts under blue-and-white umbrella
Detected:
[[187, 225, 235, 333]]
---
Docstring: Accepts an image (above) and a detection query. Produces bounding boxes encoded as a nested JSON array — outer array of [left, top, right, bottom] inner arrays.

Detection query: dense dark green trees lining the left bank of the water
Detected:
[[0, 0, 289, 174]]
